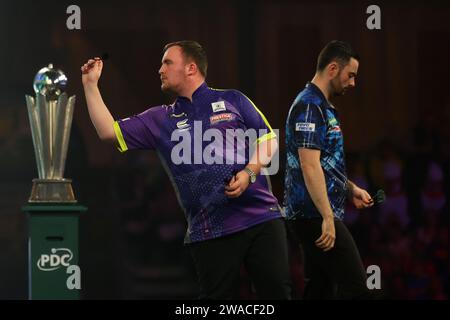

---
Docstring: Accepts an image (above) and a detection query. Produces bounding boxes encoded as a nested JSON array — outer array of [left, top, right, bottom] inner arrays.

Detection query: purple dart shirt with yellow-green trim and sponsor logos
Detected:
[[114, 83, 282, 243]]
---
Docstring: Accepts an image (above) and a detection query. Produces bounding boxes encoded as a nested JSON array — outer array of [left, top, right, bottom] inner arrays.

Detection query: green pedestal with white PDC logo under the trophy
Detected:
[[22, 203, 87, 300]]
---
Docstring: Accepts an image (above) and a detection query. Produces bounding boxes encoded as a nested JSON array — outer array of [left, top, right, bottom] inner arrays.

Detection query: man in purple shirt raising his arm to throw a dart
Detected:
[[81, 41, 291, 299]]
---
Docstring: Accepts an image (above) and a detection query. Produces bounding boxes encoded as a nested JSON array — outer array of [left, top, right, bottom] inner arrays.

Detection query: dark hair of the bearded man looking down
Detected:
[[316, 40, 359, 71]]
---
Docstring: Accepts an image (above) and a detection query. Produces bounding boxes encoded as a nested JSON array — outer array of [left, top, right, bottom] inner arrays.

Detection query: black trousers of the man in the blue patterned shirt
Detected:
[[289, 218, 374, 300]]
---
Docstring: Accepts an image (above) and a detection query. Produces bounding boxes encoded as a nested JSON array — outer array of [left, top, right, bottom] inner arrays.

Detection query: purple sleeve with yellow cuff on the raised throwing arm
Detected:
[[114, 109, 156, 152]]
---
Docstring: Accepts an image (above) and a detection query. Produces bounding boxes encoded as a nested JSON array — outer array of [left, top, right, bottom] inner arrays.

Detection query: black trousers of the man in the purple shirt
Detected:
[[189, 219, 291, 300]]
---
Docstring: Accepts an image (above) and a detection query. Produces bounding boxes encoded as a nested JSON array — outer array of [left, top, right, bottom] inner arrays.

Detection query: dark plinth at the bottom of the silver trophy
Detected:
[[28, 179, 77, 203]]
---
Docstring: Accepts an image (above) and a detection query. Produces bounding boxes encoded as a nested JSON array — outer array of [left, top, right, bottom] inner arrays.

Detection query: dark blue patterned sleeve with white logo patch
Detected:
[[291, 104, 327, 150]]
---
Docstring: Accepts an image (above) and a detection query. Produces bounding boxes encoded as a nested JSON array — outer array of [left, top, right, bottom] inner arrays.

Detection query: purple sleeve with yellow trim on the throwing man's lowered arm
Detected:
[[237, 91, 276, 144]]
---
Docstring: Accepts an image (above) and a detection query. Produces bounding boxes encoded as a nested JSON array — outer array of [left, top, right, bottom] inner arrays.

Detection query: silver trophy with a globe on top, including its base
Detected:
[[25, 64, 77, 203]]
